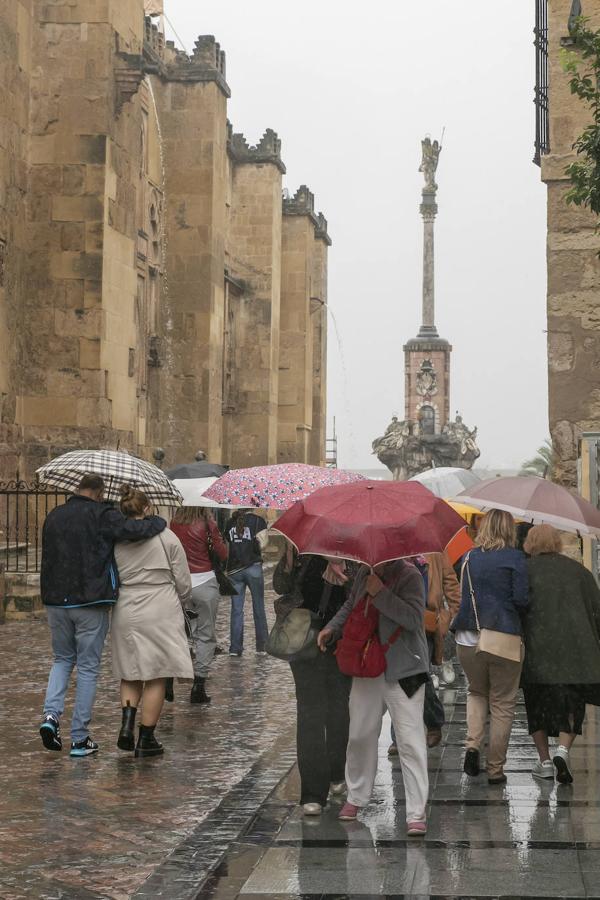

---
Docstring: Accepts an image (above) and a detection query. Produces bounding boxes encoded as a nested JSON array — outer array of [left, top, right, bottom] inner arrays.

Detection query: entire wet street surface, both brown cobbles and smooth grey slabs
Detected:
[[0, 605, 600, 900]]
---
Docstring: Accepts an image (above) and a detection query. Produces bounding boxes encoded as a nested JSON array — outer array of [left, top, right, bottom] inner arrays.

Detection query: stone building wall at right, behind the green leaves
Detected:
[[535, 0, 600, 487]]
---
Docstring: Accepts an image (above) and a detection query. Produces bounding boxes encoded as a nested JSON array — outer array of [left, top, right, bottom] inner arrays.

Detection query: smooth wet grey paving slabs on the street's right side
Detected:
[[202, 686, 600, 900]]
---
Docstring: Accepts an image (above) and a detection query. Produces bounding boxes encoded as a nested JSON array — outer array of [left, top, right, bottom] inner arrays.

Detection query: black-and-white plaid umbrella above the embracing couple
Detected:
[[36, 450, 183, 506]]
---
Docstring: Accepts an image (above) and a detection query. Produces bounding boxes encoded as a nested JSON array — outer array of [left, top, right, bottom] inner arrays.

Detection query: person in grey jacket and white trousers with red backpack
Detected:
[[318, 560, 429, 837]]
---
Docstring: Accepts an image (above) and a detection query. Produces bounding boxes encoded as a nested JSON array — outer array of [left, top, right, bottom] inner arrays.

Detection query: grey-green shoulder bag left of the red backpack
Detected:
[[265, 582, 332, 662]]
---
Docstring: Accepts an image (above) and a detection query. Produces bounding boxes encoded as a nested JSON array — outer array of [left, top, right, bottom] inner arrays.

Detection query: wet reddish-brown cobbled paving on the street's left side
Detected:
[[0, 576, 294, 900]]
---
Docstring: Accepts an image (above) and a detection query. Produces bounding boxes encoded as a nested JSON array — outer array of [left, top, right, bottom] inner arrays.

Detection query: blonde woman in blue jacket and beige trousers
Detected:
[[452, 509, 528, 784]]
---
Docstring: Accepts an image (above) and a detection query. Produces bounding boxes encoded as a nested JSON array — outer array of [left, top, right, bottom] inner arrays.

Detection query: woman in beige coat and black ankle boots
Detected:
[[111, 485, 194, 756]]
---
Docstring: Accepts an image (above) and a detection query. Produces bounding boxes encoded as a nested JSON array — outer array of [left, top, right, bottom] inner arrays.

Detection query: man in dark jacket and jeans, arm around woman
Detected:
[[40, 475, 166, 756]]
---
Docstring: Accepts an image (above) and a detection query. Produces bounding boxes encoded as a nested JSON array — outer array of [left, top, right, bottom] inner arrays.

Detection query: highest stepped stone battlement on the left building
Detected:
[[144, 16, 231, 97]]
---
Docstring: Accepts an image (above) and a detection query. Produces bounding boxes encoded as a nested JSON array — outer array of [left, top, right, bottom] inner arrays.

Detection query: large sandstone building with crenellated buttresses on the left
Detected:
[[0, 0, 331, 479]]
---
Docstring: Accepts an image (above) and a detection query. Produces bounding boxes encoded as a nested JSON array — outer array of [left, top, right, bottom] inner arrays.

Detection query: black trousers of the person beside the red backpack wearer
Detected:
[[290, 653, 352, 806]]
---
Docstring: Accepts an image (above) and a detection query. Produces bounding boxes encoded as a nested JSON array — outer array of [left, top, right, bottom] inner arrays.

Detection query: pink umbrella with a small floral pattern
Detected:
[[203, 463, 364, 510]]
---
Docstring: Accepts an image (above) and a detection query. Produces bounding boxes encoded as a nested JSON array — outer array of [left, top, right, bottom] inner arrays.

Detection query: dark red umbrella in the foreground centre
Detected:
[[273, 480, 465, 567]]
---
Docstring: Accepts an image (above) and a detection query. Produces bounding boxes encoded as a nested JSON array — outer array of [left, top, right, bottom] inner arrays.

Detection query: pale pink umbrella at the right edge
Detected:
[[456, 475, 600, 537]]
